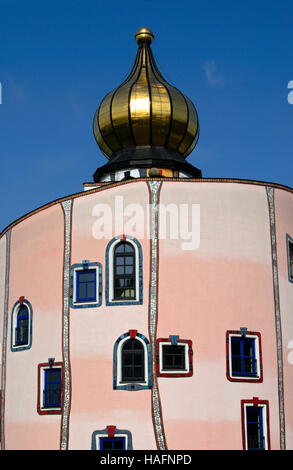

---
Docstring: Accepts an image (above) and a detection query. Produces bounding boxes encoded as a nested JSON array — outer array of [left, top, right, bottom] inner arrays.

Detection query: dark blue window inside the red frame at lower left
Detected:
[[43, 367, 62, 408]]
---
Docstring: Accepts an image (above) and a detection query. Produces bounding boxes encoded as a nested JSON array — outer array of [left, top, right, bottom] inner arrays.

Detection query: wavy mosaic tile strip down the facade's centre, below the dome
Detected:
[[148, 181, 167, 450]]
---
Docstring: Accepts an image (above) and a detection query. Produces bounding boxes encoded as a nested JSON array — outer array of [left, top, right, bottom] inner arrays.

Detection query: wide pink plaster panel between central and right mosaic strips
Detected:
[[157, 183, 279, 449]]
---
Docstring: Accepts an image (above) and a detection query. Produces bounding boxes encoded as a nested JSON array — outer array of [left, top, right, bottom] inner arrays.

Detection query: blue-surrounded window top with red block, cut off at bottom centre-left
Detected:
[[91, 426, 132, 450]]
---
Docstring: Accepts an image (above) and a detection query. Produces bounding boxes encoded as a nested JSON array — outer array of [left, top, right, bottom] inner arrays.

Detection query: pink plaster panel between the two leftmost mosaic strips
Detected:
[[5, 205, 64, 449]]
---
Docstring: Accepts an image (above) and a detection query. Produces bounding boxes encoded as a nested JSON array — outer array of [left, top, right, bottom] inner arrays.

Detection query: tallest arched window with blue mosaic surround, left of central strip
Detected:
[[106, 235, 142, 305]]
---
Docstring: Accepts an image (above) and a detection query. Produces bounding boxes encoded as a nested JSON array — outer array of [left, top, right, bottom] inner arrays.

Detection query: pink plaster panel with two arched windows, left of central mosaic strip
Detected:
[[69, 183, 156, 449]]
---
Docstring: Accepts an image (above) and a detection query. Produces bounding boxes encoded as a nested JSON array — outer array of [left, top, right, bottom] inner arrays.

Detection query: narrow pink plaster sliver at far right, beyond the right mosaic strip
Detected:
[[275, 190, 293, 449]]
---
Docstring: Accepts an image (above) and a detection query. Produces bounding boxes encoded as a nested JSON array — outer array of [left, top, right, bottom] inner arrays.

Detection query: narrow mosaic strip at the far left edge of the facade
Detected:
[[1, 230, 11, 450]]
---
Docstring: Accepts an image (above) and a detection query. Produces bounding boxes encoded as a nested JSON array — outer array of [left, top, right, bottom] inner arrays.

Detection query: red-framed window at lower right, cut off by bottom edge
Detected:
[[241, 397, 270, 450]]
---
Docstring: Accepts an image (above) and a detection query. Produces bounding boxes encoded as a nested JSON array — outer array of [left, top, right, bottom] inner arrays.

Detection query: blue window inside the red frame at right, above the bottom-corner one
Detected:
[[231, 337, 257, 377]]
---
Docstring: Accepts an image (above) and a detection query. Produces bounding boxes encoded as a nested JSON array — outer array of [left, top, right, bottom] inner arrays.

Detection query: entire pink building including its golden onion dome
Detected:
[[0, 28, 293, 450]]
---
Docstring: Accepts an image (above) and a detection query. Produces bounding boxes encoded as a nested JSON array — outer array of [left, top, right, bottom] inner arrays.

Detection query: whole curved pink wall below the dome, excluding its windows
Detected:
[[0, 179, 293, 449]]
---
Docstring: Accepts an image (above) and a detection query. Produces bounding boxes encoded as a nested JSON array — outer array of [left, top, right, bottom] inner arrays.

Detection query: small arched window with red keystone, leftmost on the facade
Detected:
[[11, 297, 32, 351]]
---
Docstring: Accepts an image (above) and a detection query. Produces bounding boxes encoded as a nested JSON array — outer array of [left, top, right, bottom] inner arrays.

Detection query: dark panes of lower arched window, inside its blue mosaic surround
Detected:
[[122, 338, 145, 383]]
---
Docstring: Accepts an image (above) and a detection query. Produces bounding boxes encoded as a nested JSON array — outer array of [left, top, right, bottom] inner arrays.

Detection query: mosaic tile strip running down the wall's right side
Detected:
[[266, 186, 286, 450]]
